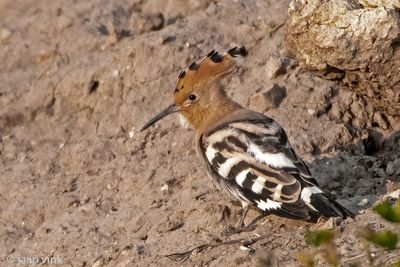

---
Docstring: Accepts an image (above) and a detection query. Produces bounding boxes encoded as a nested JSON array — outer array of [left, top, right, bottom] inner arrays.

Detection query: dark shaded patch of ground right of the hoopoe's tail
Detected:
[[307, 130, 400, 214]]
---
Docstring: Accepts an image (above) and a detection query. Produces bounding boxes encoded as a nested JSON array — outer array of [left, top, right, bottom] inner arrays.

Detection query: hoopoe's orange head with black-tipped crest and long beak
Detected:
[[141, 46, 247, 131]]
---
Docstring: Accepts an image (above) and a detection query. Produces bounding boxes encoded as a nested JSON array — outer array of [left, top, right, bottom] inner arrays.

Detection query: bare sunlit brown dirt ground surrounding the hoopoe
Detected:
[[0, 0, 400, 267]]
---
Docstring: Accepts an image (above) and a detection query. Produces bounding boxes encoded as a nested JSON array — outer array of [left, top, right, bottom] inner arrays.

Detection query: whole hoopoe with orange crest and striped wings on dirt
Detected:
[[142, 46, 352, 228]]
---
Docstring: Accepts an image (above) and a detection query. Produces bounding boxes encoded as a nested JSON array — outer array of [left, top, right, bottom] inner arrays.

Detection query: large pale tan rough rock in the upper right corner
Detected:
[[287, 0, 400, 70]]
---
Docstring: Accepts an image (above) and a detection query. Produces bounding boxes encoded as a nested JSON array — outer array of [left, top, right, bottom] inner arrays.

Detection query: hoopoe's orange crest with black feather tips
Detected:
[[175, 46, 248, 93]]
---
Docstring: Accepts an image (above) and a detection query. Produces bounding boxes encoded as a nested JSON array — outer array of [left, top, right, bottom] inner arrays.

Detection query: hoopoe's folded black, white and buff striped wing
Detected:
[[201, 117, 322, 219]]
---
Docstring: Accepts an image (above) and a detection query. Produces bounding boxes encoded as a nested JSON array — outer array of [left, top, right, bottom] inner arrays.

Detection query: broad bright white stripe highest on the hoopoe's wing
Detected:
[[247, 143, 296, 168]]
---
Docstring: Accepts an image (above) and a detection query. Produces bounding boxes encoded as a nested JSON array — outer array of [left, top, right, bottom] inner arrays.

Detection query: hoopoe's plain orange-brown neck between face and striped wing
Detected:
[[182, 89, 242, 134]]
